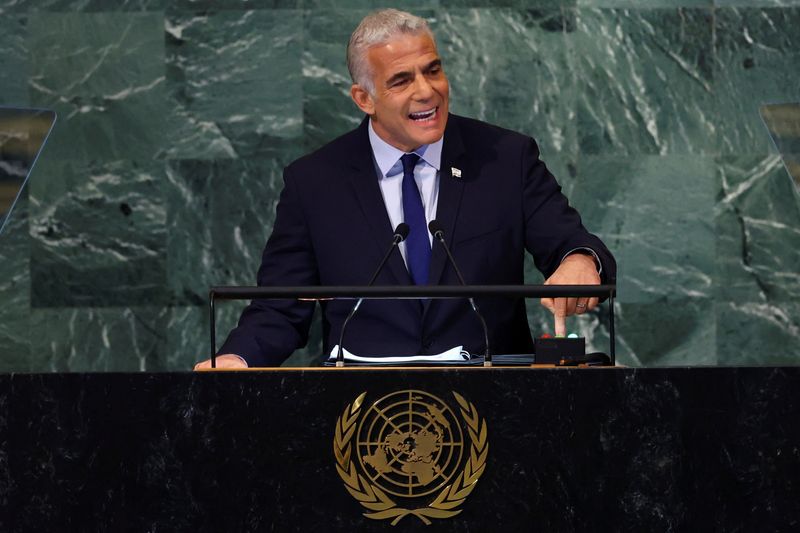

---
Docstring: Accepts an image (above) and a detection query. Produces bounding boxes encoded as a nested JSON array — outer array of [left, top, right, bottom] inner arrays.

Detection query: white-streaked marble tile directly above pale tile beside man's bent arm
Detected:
[[571, 9, 717, 156]]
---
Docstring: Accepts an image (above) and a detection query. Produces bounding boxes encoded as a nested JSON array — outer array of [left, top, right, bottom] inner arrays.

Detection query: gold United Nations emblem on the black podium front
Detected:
[[333, 390, 489, 525]]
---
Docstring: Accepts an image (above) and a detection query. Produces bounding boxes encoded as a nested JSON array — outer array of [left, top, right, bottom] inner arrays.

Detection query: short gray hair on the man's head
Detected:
[[347, 9, 435, 95]]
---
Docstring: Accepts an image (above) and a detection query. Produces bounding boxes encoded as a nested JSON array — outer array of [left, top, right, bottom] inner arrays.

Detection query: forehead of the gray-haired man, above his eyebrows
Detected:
[[367, 32, 439, 76]]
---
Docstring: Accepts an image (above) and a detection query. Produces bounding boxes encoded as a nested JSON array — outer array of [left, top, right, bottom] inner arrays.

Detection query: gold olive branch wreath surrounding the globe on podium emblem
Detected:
[[333, 392, 489, 526]]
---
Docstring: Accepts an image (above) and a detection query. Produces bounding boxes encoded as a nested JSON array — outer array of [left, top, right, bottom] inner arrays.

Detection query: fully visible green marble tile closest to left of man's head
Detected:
[[164, 10, 303, 163]]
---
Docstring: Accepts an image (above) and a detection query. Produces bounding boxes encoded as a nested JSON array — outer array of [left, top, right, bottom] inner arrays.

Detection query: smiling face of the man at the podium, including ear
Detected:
[[350, 33, 450, 152]]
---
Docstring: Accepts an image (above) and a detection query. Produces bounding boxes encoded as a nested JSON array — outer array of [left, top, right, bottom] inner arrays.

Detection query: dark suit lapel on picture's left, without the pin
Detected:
[[349, 119, 416, 285]]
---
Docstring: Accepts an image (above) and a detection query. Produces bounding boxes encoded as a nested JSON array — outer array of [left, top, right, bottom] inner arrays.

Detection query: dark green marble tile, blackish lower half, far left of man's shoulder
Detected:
[[29, 160, 168, 308]]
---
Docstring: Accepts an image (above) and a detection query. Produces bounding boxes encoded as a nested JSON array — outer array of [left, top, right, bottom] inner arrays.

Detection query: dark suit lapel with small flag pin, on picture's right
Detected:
[[428, 115, 470, 285]]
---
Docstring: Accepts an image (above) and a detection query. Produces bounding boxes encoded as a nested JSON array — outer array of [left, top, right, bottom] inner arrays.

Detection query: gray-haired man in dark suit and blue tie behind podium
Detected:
[[197, 10, 616, 368]]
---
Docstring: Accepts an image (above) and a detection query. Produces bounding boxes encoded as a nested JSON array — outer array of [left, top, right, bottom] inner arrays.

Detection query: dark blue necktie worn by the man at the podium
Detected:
[[400, 154, 431, 285]]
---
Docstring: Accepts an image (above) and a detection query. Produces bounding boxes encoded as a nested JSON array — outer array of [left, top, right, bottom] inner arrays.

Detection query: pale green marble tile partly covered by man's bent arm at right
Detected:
[[572, 155, 715, 303]]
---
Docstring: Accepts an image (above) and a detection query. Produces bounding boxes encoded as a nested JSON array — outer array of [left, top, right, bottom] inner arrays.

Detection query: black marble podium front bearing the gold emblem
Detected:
[[0, 367, 800, 532]]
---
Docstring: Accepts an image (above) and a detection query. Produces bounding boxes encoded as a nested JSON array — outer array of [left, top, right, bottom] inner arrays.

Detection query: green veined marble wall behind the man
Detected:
[[0, 0, 800, 371]]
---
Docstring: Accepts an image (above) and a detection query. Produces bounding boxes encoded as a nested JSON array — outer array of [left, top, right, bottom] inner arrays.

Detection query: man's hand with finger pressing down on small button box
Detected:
[[541, 253, 600, 336]]
